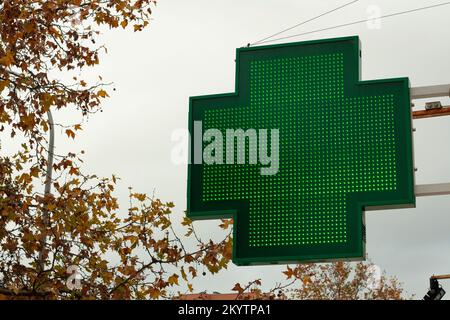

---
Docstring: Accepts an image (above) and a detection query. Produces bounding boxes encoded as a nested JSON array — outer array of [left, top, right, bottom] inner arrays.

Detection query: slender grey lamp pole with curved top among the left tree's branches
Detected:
[[38, 110, 55, 272]]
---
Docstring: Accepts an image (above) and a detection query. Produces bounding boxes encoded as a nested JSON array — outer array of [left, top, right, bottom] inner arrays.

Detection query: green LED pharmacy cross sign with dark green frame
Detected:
[[187, 37, 415, 265]]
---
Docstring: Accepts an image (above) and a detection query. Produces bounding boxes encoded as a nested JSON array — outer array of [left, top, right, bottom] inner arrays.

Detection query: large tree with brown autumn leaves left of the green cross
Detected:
[[0, 0, 236, 299]]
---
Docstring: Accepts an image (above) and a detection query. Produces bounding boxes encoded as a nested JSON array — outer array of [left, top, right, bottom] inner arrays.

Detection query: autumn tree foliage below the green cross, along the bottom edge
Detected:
[[232, 262, 406, 300]]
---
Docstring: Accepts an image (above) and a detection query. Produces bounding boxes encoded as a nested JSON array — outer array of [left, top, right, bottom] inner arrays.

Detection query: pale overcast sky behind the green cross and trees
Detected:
[[6, 0, 450, 298]]
